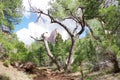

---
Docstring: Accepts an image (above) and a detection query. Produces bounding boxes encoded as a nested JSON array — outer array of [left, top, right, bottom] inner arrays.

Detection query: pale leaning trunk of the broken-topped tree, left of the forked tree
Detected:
[[44, 39, 61, 71]]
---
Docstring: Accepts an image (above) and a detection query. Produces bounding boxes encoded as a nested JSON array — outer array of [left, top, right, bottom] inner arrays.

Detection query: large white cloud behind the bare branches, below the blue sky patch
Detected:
[[16, 22, 68, 45]]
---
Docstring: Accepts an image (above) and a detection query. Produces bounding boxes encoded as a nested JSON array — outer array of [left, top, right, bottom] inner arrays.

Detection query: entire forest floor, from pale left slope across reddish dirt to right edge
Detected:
[[0, 61, 120, 80]]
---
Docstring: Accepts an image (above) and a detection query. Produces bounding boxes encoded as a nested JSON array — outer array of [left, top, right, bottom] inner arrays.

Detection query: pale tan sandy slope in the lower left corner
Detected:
[[0, 61, 32, 80]]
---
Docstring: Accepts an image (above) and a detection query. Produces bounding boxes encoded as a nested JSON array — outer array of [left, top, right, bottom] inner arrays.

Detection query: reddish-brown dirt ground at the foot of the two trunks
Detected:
[[33, 68, 80, 80]]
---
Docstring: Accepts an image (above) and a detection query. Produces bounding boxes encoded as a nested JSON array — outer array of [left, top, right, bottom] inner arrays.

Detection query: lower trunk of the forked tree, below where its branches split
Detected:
[[65, 37, 76, 71]]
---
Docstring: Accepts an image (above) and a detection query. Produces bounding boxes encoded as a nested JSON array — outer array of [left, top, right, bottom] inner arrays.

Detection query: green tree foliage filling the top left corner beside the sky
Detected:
[[0, 0, 22, 30]]
